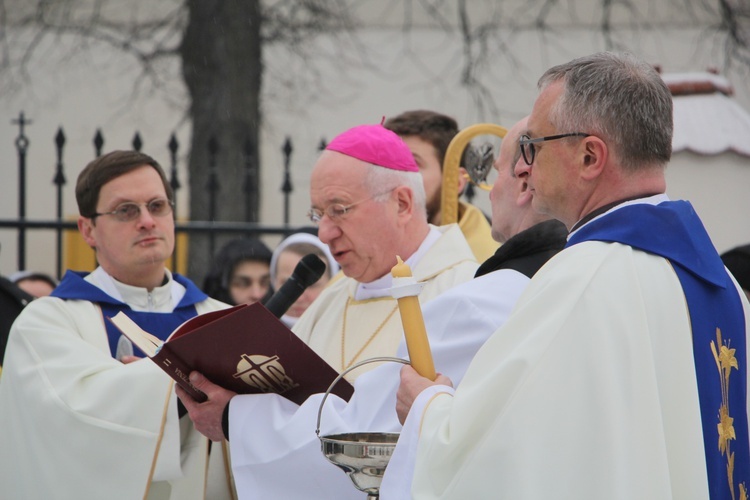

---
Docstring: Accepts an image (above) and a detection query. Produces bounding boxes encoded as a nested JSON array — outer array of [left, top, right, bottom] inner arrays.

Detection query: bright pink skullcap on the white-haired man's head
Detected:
[[326, 125, 419, 172]]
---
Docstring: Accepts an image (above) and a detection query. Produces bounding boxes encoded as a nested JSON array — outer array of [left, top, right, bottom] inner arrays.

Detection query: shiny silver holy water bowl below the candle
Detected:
[[320, 432, 398, 499]]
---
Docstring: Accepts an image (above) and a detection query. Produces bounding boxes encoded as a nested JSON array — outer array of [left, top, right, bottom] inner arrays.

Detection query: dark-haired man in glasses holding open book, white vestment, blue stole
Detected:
[[0, 151, 233, 500]]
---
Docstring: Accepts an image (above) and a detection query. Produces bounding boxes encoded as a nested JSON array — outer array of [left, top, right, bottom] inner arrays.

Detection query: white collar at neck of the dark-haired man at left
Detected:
[[86, 267, 186, 312]]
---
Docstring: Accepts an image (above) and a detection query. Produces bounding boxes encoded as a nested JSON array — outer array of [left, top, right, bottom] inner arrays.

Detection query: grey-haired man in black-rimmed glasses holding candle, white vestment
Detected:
[[388, 53, 750, 500]]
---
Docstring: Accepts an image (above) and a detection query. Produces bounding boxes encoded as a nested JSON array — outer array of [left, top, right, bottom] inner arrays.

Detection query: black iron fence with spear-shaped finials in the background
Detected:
[[0, 112, 325, 279]]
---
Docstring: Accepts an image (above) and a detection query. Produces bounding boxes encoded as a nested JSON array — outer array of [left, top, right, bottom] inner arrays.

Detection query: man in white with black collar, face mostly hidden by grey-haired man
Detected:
[[178, 121, 567, 500]]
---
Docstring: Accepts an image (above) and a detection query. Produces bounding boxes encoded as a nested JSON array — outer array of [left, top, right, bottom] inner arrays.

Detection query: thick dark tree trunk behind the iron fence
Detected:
[[180, 0, 262, 286]]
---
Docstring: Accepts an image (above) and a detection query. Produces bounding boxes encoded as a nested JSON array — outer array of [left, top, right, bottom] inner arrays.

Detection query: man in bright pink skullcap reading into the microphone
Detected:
[[292, 125, 477, 381]]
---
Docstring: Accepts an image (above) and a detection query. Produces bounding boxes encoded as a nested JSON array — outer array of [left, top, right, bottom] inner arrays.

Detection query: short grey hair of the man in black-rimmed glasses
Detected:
[[539, 52, 673, 171]]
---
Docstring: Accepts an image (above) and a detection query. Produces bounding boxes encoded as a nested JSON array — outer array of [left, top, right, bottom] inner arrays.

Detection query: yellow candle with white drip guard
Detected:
[[391, 256, 437, 380]]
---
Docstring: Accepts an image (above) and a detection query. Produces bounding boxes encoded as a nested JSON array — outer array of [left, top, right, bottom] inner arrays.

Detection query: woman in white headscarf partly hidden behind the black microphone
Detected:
[[271, 230, 339, 328]]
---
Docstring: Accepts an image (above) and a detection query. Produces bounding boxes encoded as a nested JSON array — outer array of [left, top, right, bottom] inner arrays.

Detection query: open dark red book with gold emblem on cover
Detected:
[[109, 303, 354, 404]]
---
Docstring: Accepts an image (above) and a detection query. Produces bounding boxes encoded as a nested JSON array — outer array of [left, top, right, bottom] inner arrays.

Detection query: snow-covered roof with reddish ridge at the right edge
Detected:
[[662, 73, 750, 157]]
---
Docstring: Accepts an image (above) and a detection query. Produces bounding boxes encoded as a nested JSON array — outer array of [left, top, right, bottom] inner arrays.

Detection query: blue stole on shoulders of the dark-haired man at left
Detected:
[[52, 271, 208, 357]]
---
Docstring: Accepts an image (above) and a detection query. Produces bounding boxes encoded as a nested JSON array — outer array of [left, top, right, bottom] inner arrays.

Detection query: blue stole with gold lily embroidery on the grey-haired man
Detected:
[[567, 201, 750, 500]]
